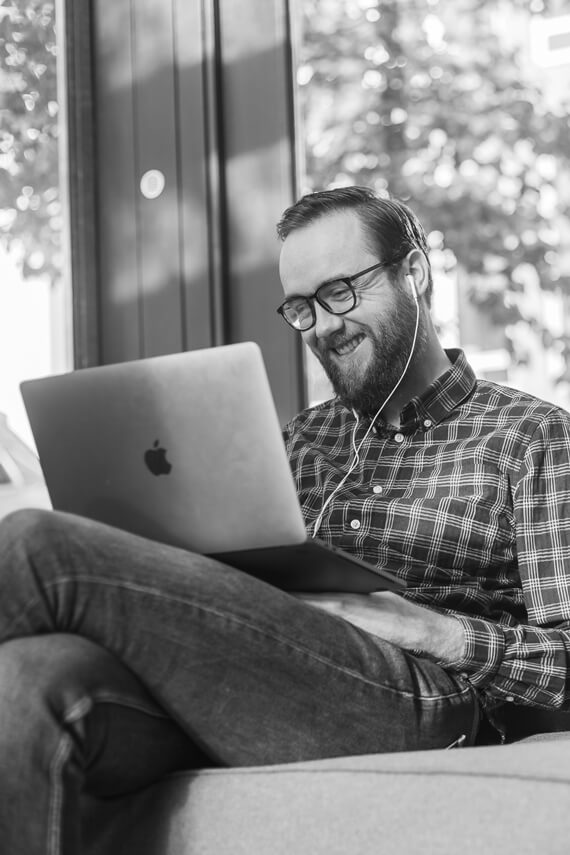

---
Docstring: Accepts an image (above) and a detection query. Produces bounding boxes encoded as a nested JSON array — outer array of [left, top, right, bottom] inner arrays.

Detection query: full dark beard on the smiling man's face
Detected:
[[315, 288, 424, 417]]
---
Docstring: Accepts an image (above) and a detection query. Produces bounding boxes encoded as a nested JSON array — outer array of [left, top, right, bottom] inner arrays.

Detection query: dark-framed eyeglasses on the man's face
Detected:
[[277, 261, 391, 332]]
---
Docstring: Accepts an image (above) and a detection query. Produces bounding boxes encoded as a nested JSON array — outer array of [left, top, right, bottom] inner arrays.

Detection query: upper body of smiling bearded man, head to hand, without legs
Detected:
[[279, 188, 570, 736]]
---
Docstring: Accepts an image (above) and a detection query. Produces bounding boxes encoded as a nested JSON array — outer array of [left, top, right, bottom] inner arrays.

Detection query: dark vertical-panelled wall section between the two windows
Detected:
[[67, 0, 303, 420]]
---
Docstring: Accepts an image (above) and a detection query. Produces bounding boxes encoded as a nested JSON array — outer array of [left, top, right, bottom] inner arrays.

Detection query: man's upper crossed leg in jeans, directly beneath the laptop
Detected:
[[0, 511, 478, 765]]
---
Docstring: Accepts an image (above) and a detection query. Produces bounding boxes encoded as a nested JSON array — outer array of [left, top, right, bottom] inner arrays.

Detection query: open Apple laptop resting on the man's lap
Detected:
[[20, 342, 405, 593]]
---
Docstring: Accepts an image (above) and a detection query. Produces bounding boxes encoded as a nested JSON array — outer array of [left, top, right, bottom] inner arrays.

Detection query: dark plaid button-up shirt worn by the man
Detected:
[[284, 350, 570, 709]]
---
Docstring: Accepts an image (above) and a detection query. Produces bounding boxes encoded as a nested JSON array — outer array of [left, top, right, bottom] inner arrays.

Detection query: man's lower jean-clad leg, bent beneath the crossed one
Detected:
[[0, 634, 205, 855]]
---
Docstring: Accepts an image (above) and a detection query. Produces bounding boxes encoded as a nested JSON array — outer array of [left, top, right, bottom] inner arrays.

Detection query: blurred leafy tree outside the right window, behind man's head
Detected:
[[297, 0, 570, 380]]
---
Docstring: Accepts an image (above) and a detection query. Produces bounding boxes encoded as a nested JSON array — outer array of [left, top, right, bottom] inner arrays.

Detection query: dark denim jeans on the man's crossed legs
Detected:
[[0, 511, 479, 855]]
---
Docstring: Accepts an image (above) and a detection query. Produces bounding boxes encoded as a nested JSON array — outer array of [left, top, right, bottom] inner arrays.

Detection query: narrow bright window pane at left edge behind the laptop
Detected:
[[0, 0, 72, 515]]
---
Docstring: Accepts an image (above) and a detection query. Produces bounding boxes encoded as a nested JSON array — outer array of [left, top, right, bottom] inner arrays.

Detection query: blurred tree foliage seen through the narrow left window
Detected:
[[0, 0, 61, 281]]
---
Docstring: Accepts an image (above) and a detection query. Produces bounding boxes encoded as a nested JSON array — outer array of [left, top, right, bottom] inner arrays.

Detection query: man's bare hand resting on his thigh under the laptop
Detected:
[[295, 591, 465, 662]]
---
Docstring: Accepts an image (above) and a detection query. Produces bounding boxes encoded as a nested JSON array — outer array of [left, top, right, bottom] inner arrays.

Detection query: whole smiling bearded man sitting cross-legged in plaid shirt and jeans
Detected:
[[0, 188, 570, 855]]
